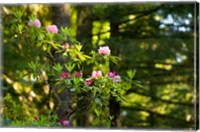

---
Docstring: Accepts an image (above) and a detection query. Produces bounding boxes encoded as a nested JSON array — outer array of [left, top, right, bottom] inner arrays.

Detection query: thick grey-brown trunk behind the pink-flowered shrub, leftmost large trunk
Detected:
[[52, 4, 72, 120]]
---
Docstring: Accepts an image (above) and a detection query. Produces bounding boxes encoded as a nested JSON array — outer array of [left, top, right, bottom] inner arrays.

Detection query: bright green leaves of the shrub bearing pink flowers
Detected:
[[1, 7, 139, 127]]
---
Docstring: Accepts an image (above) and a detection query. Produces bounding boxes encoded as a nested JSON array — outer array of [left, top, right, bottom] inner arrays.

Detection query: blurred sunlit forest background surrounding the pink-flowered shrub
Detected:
[[1, 2, 199, 129]]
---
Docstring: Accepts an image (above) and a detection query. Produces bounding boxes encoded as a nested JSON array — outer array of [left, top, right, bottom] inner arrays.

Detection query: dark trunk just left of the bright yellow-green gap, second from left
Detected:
[[76, 5, 92, 127]]
